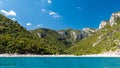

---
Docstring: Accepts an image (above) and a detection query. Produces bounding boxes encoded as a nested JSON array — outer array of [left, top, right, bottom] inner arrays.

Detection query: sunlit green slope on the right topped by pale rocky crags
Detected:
[[66, 12, 120, 55]]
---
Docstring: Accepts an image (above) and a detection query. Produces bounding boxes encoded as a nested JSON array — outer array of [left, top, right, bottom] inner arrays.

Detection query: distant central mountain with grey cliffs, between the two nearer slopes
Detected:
[[30, 28, 95, 54]]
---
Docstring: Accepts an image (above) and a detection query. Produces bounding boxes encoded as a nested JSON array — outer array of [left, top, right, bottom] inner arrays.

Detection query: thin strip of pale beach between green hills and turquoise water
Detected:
[[0, 54, 120, 57]]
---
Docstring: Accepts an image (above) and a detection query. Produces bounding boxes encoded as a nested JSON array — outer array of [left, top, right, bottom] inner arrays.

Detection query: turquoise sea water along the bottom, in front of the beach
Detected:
[[0, 57, 120, 68]]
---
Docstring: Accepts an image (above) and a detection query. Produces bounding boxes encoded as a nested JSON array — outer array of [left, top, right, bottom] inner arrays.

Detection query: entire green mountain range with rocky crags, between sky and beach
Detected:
[[0, 12, 120, 55]]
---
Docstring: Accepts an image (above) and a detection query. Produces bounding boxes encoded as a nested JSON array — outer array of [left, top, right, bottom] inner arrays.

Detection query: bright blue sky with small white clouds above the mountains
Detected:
[[0, 0, 120, 30]]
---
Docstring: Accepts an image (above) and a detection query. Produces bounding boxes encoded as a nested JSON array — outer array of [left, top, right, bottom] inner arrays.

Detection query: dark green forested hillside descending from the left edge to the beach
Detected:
[[0, 14, 66, 54]]
